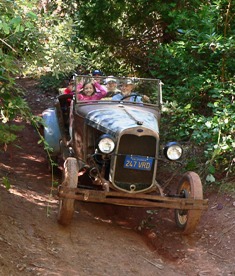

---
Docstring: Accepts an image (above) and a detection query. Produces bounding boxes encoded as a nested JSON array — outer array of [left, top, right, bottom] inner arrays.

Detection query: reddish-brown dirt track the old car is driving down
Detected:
[[0, 80, 235, 276]]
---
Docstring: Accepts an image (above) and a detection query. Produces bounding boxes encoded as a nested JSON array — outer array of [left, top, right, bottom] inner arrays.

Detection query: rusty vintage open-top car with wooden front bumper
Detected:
[[43, 76, 207, 234]]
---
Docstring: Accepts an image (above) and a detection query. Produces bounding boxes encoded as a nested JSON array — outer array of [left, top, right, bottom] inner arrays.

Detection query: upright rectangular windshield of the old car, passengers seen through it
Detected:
[[74, 75, 162, 108]]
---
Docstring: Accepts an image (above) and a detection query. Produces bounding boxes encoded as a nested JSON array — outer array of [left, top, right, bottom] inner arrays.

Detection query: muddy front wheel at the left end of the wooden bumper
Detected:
[[58, 157, 78, 225]]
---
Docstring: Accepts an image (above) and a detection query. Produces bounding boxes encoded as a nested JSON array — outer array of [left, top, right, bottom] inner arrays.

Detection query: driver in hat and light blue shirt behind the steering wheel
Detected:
[[112, 79, 149, 103]]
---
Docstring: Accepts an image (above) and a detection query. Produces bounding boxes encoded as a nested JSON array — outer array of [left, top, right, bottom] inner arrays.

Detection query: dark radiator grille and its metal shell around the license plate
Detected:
[[113, 130, 159, 192]]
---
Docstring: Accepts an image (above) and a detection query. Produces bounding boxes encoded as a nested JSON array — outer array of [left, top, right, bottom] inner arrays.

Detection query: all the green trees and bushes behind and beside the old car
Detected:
[[0, 0, 235, 189]]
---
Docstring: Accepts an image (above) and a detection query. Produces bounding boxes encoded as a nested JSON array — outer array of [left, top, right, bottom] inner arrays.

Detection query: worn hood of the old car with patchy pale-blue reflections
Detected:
[[86, 105, 159, 136]]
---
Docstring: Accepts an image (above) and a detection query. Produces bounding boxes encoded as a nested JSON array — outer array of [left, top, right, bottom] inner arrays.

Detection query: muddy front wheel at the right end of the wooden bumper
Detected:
[[175, 172, 203, 234]]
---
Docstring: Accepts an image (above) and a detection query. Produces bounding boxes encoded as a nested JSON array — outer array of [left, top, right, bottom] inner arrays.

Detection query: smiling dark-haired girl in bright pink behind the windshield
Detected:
[[77, 80, 107, 101]]
